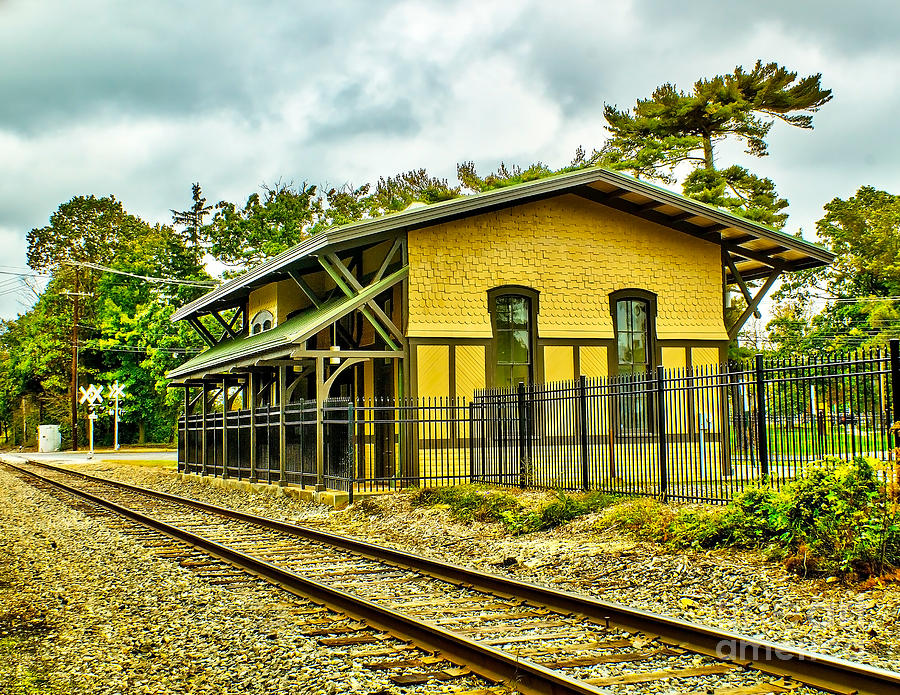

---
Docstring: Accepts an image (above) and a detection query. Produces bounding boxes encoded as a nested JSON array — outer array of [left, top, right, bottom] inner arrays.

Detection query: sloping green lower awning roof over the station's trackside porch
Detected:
[[166, 268, 409, 379]]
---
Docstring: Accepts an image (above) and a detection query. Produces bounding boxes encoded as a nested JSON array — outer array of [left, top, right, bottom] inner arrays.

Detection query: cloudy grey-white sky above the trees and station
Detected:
[[0, 0, 900, 317]]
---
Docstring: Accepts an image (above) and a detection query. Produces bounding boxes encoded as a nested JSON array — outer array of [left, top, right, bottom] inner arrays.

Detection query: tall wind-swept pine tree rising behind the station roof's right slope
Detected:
[[598, 61, 831, 226]]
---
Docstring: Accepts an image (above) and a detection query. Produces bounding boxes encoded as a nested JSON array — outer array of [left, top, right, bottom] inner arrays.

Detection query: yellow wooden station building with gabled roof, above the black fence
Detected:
[[170, 168, 832, 492]]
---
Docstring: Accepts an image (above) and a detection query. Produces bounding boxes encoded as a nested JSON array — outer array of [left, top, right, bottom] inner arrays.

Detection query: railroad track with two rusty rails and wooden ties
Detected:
[[5, 462, 900, 695]]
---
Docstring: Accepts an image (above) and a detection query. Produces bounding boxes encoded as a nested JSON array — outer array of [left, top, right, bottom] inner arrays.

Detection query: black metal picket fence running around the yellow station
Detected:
[[179, 341, 900, 502]]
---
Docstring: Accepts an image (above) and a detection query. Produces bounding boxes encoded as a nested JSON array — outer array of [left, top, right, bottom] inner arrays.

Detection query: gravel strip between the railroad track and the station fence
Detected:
[[14, 465, 900, 684]]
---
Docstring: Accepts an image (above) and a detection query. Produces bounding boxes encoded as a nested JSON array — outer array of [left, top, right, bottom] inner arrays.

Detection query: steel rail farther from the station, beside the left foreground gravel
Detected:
[[2, 461, 607, 695]]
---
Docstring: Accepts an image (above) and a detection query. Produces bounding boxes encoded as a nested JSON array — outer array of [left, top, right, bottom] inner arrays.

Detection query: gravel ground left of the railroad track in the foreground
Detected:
[[0, 462, 500, 695]]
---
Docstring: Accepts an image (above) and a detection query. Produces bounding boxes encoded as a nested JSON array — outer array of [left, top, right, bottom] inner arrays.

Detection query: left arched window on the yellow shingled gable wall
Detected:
[[488, 287, 538, 388]]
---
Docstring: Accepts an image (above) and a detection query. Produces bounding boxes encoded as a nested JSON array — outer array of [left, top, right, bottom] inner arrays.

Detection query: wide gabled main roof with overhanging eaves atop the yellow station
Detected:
[[172, 167, 834, 321]]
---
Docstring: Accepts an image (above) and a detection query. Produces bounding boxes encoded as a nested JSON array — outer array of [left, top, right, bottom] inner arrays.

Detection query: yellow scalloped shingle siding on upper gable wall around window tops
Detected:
[[408, 195, 727, 341]]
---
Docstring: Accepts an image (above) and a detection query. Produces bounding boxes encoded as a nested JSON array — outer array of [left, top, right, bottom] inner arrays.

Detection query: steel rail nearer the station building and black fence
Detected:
[[8, 461, 900, 695]]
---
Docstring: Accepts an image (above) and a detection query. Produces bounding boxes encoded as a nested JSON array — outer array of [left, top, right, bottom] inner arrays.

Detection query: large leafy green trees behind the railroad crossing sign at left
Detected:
[[11, 194, 209, 441]]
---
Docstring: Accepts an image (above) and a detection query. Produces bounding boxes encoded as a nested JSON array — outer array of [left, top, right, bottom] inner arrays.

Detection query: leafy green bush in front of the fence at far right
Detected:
[[602, 458, 900, 576]]
